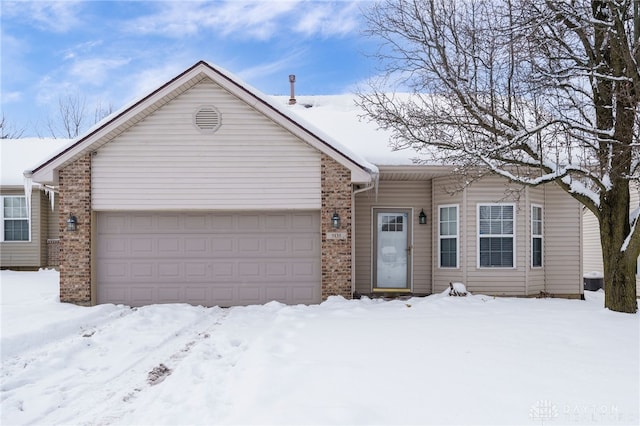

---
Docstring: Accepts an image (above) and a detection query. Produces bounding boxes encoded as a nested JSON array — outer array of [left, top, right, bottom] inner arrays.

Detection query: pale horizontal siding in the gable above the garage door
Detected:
[[92, 79, 320, 210]]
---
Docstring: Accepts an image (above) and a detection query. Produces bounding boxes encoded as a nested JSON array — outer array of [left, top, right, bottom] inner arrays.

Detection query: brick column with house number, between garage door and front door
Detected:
[[320, 154, 352, 300]]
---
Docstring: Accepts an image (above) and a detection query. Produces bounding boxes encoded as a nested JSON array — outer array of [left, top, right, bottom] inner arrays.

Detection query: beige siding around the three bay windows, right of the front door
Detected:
[[431, 177, 581, 296]]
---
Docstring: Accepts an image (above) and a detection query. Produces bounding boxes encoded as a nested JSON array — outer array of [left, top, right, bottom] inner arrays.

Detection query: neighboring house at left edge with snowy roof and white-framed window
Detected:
[[0, 138, 69, 269]]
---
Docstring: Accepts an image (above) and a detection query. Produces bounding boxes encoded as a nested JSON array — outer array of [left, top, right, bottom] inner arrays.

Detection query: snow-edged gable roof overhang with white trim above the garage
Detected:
[[25, 61, 378, 184]]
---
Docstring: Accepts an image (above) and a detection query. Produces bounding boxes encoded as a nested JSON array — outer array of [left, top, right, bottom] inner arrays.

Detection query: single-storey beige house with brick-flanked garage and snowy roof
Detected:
[[25, 62, 583, 306]]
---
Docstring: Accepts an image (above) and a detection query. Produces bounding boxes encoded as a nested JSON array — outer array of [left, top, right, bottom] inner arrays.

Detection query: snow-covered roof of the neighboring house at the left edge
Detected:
[[0, 138, 71, 186]]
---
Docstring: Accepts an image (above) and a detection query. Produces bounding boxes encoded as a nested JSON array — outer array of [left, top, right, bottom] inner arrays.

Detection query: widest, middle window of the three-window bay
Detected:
[[478, 204, 515, 268]]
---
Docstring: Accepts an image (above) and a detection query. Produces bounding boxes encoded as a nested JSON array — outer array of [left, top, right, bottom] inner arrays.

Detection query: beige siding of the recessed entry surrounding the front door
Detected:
[[354, 181, 434, 294]]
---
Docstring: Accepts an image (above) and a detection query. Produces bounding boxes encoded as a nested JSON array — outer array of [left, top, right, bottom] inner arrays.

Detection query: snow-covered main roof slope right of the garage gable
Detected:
[[272, 94, 417, 166]]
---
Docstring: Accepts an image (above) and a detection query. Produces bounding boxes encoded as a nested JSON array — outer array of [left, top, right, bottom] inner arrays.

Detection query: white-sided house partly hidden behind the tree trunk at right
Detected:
[[582, 187, 640, 297]]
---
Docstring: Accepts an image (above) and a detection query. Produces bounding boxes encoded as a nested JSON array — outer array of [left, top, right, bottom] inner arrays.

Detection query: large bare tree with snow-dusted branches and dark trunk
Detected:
[[360, 0, 640, 312]]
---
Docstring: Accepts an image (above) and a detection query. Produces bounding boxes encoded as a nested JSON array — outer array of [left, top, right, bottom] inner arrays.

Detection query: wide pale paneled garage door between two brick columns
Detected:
[[96, 212, 321, 306]]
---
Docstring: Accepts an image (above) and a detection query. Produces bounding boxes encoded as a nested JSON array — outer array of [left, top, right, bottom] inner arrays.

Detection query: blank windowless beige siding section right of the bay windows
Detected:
[[545, 184, 583, 295]]
